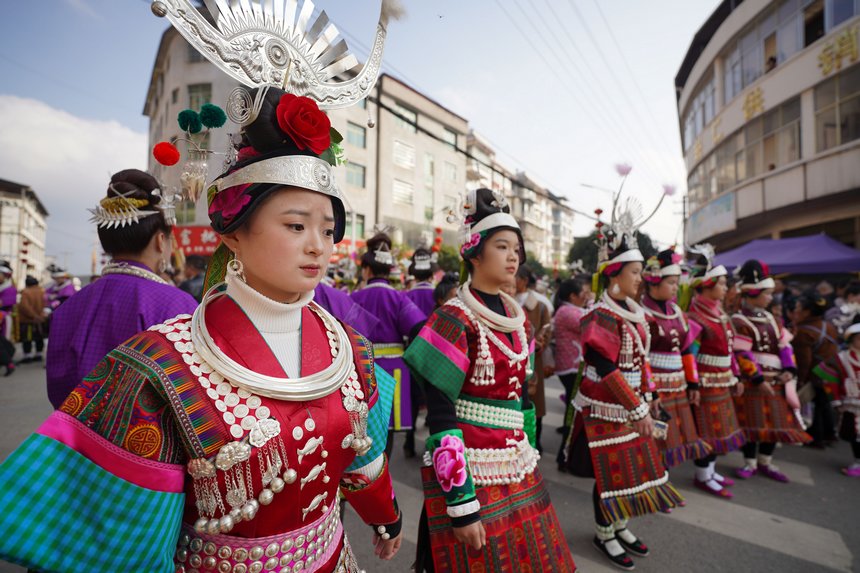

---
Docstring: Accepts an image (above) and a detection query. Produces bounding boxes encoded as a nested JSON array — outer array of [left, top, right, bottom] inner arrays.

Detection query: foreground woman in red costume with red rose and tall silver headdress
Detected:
[[0, 2, 401, 573]]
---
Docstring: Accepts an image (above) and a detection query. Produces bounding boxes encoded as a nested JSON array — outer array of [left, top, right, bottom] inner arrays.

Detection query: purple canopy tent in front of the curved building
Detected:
[[714, 233, 860, 275]]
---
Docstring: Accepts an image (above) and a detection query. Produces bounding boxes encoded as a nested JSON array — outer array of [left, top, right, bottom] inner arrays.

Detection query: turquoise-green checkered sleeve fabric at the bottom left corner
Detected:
[[0, 434, 185, 573]]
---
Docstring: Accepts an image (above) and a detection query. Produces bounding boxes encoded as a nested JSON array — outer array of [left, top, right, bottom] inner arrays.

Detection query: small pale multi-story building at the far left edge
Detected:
[[0, 179, 48, 288]]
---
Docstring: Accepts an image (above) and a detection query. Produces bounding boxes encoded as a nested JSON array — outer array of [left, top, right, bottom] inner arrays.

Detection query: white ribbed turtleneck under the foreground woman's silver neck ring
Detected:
[[227, 279, 314, 378]]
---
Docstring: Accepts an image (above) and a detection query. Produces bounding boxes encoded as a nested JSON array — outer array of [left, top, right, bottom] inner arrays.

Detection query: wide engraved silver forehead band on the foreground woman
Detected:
[[212, 155, 341, 199]]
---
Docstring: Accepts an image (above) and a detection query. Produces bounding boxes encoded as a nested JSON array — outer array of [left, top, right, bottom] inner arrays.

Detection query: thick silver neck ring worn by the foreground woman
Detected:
[[191, 280, 353, 402]]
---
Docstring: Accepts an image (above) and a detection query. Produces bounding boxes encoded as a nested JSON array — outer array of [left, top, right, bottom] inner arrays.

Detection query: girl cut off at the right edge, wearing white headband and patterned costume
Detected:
[[814, 313, 860, 477]]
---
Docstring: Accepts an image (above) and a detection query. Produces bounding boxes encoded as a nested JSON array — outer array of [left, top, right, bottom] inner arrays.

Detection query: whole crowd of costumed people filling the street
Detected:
[[0, 2, 860, 573]]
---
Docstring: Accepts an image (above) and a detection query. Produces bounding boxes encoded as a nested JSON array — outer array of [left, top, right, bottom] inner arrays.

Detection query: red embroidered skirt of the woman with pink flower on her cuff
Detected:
[[421, 467, 576, 573]]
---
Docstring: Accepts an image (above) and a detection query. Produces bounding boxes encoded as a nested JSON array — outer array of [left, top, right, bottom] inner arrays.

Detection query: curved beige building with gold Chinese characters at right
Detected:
[[675, 0, 860, 250]]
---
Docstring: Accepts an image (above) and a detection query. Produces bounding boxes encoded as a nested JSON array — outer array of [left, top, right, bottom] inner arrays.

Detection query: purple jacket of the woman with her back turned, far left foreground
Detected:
[[46, 265, 197, 408]]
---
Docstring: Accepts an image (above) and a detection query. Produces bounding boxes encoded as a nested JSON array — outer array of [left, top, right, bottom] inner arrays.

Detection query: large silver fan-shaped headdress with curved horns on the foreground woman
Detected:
[[152, 0, 402, 109]]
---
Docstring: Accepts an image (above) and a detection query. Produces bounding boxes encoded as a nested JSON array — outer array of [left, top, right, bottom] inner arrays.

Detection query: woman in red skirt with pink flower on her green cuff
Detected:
[[404, 189, 575, 572]]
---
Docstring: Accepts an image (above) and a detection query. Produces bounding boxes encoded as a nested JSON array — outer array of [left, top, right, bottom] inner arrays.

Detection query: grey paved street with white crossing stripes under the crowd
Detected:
[[0, 365, 860, 573]]
